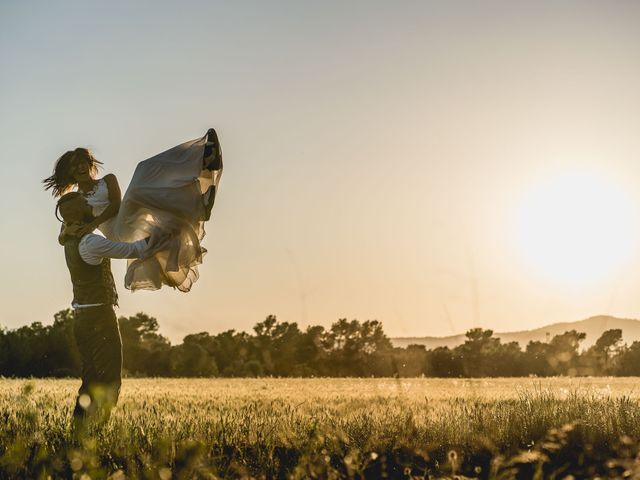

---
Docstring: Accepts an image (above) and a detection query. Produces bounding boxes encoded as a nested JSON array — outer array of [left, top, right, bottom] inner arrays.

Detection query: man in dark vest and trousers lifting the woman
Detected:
[[56, 192, 149, 433]]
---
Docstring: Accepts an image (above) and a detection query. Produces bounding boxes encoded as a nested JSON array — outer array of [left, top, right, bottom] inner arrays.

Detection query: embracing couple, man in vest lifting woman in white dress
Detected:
[[44, 129, 222, 434]]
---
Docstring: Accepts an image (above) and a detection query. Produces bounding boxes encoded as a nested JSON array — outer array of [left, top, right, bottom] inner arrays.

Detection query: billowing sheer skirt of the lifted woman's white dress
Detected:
[[115, 129, 222, 292]]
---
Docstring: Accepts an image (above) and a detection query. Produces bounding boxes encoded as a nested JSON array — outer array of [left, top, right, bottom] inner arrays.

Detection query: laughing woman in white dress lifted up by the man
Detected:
[[44, 129, 222, 292]]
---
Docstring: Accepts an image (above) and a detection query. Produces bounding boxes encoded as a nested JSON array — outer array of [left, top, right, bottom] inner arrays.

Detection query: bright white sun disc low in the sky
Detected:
[[515, 172, 637, 286]]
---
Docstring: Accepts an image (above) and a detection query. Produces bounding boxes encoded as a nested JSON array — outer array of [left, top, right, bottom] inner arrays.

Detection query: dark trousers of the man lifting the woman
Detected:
[[73, 305, 122, 430]]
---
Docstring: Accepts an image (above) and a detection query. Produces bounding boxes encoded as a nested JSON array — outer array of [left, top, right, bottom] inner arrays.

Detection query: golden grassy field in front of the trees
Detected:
[[0, 378, 640, 480]]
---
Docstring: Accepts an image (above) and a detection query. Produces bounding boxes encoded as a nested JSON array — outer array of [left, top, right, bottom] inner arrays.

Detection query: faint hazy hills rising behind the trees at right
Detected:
[[391, 315, 640, 349]]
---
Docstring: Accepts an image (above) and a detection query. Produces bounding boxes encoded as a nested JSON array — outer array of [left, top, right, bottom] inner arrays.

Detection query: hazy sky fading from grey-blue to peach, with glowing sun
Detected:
[[0, 0, 640, 342]]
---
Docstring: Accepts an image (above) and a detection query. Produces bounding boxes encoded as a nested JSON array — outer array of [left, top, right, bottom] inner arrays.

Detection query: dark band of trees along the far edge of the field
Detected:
[[0, 309, 640, 377]]
